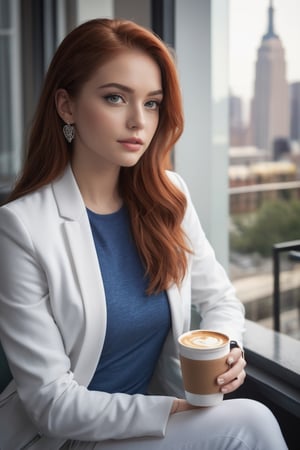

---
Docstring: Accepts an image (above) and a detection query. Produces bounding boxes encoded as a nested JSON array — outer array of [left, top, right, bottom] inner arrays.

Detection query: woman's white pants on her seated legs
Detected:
[[63, 399, 287, 450]]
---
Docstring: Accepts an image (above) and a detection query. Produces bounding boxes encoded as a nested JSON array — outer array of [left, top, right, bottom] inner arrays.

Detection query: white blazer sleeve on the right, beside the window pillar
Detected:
[[166, 173, 245, 345]]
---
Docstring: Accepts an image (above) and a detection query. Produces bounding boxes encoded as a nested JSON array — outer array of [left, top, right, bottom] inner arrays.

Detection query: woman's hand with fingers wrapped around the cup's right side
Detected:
[[217, 348, 246, 394]]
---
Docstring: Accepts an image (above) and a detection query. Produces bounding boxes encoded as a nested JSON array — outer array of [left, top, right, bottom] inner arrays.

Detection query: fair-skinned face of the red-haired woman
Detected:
[[71, 50, 163, 168]]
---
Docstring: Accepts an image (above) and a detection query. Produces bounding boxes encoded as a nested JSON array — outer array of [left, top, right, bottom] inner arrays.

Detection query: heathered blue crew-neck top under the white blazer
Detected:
[[87, 206, 171, 394]]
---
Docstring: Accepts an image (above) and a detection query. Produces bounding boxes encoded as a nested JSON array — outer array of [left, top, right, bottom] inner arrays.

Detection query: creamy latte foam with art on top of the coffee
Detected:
[[180, 330, 228, 349]]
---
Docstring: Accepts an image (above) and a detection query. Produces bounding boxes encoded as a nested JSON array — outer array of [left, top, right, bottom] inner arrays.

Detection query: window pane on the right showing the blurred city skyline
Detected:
[[228, 0, 300, 339]]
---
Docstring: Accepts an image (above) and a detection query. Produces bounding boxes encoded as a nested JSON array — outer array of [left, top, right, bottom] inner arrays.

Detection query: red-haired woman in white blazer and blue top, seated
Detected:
[[0, 19, 286, 450]]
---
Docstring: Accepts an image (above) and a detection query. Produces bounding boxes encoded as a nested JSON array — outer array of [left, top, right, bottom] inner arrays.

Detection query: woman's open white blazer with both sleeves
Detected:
[[0, 167, 244, 450]]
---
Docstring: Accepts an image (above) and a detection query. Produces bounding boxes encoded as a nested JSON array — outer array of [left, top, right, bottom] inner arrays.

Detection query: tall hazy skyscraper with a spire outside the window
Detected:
[[252, 0, 290, 156]]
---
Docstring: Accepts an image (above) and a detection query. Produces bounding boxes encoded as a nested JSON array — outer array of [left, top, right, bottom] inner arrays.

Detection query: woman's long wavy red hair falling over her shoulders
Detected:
[[9, 19, 189, 293]]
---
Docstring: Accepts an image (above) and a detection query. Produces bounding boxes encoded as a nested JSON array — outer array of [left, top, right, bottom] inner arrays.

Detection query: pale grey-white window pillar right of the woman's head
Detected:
[[175, 0, 228, 268]]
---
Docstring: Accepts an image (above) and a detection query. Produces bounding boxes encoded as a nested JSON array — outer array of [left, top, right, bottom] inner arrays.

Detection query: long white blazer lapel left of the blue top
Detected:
[[53, 167, 106, 384]]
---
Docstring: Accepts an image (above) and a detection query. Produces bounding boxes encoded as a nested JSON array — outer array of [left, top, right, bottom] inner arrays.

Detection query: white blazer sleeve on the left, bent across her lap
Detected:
[[0, 206, 174, 441]]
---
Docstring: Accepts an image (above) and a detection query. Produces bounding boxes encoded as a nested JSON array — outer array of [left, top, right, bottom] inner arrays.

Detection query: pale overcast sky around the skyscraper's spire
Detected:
[[229, 0, 300, 100]]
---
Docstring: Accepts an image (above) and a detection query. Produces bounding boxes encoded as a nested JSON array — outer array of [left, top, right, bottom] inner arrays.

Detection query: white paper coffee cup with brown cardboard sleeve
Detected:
[[178, 330, 230, 406]]
